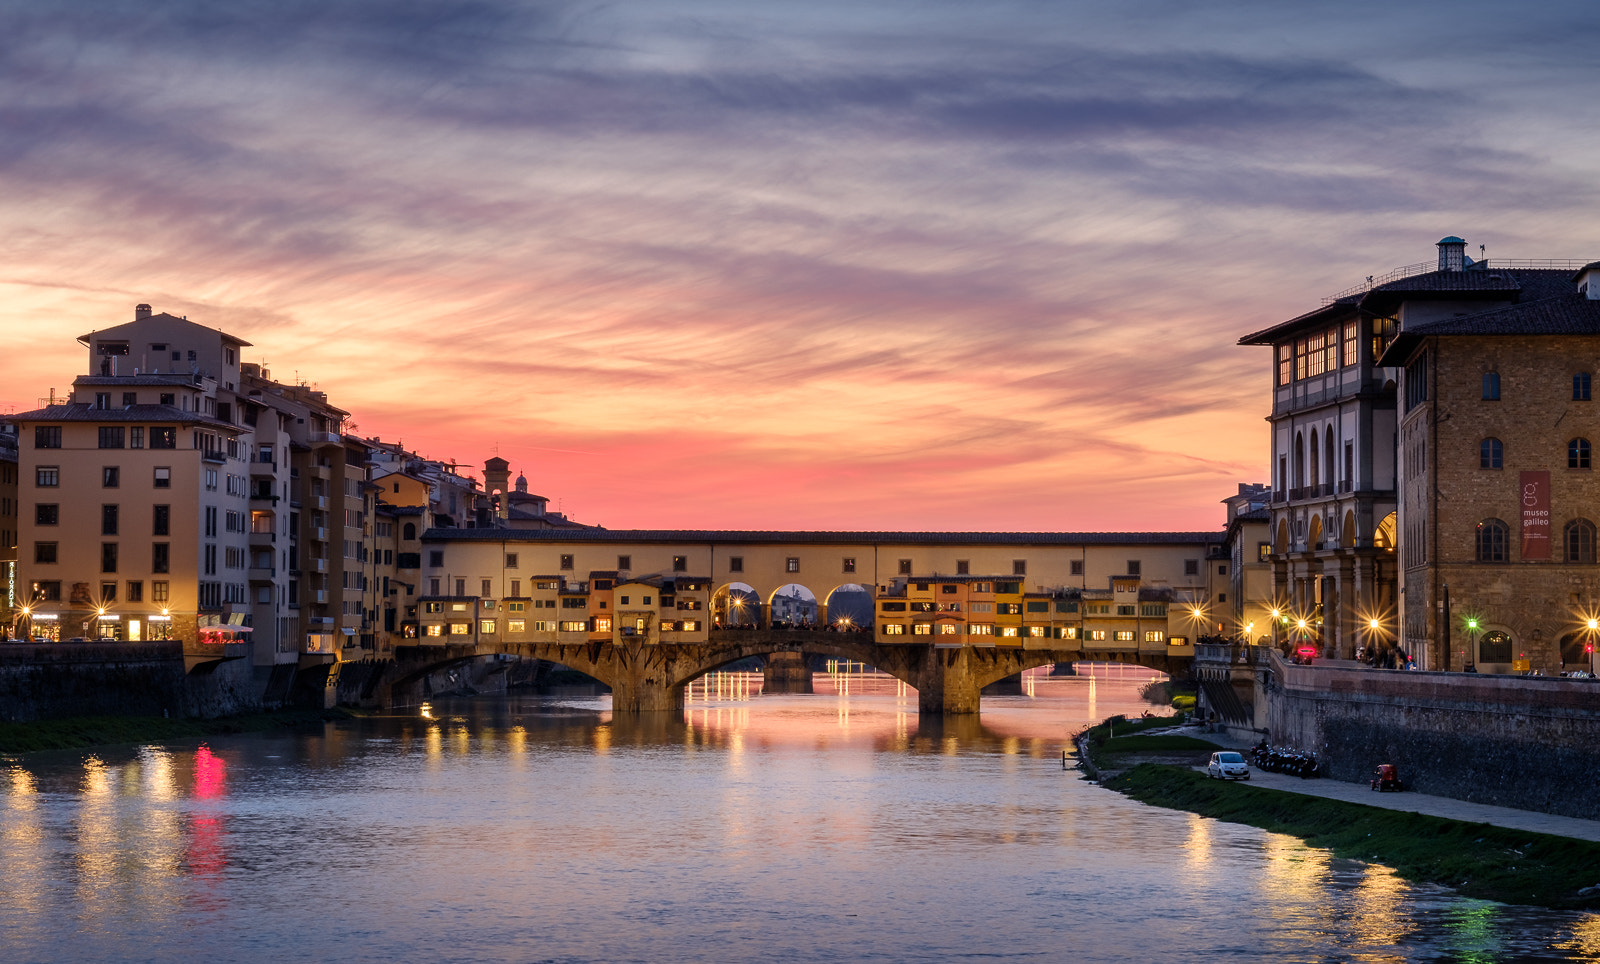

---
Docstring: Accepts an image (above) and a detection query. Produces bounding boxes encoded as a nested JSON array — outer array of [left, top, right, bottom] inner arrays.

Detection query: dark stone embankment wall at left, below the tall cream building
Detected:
[[0, 642, 262, 722]]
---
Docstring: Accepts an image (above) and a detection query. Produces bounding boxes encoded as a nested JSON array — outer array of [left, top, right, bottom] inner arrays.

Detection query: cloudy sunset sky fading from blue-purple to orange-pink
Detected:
[[0, 0, 1600, 530]]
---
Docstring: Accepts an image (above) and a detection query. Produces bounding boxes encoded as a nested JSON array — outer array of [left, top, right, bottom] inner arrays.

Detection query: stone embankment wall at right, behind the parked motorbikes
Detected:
[[1261, 660, 1600, 820]]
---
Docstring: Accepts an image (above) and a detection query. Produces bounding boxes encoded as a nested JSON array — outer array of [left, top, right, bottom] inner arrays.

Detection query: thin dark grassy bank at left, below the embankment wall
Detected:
[[0, 709, 352, 753]]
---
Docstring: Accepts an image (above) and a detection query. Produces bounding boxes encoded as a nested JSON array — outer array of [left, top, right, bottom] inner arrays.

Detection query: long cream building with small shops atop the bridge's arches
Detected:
[[419, 528, 1229, 652]]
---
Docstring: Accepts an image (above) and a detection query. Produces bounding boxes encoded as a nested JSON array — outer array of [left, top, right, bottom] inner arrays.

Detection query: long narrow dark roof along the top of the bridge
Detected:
[[422, 528, 1222, 541]]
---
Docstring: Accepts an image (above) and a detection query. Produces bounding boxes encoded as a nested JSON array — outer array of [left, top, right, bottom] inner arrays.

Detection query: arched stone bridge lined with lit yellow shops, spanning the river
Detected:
[[376, 528, 1227, 714]]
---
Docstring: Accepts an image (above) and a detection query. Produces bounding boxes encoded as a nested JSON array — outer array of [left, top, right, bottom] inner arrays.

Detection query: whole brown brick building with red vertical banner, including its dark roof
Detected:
[[1381, 264, 1600, 674]]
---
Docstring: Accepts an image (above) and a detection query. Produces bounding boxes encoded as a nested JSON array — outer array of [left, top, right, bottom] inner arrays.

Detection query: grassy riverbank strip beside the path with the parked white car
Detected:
[[1104, 764, 1600, 908]]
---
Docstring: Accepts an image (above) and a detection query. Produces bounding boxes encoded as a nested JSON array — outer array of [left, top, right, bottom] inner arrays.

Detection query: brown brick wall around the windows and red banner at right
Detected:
[[1402, 335, 1600, 673]]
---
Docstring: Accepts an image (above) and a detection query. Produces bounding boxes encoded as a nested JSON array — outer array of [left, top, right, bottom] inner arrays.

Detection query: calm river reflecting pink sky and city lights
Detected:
[[0, 682, 1600, 964]]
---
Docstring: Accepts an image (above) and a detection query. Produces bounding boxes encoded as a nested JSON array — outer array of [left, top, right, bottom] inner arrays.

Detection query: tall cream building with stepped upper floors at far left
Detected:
[[13, 304, 253, 642]]
